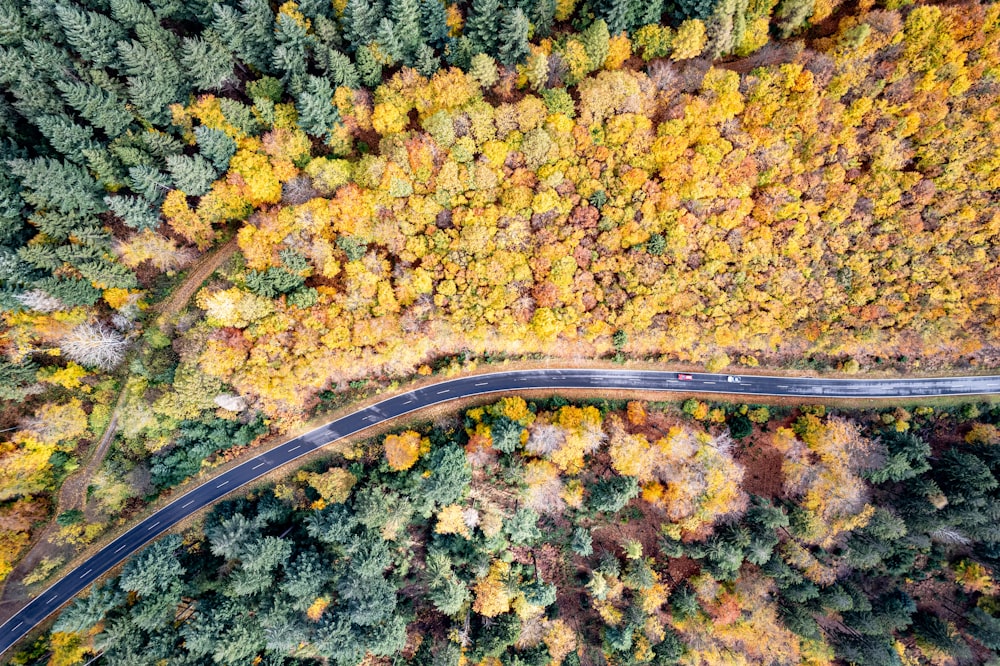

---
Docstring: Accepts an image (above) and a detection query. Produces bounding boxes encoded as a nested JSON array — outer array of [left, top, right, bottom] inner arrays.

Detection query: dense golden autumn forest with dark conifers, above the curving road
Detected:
[[0, 0, 1000, 661]]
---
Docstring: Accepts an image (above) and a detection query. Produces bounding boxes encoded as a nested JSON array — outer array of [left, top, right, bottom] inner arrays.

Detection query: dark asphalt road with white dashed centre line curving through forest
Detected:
[[0, 369, 1000, 654]]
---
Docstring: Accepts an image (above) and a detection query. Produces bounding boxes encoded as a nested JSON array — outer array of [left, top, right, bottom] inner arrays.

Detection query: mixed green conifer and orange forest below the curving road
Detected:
[[23, 396, 1000, 666]]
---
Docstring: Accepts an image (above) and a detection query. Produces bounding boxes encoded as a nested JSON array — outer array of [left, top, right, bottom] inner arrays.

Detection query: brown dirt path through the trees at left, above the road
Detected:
[[0, 237, 238, 616]]
